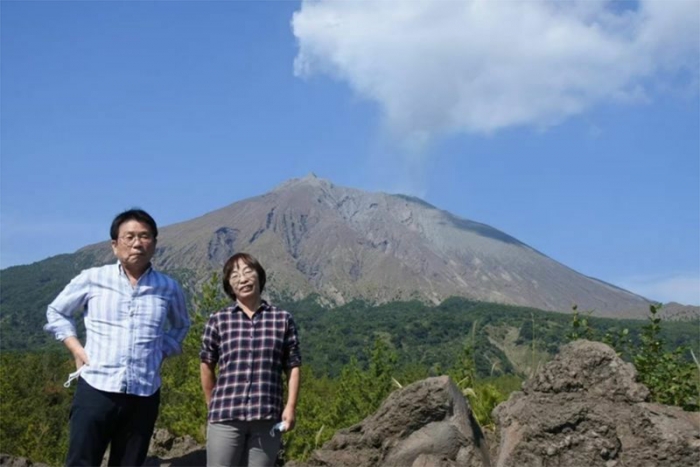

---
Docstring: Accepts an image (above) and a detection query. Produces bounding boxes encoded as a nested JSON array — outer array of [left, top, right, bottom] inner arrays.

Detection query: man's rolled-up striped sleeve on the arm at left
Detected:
[[44, 270, 90, 341]]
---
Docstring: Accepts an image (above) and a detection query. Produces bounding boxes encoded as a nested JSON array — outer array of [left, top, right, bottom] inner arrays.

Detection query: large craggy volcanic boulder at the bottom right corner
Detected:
[[494, 341, 700, 467]]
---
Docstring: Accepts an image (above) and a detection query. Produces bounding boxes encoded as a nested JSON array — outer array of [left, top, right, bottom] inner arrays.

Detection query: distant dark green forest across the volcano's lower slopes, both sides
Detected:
[[0, 251, 697, 352]]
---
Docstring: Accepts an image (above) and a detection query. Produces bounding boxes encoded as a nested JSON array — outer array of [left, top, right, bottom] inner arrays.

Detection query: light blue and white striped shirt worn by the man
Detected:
[[44, 262, 190, 396]]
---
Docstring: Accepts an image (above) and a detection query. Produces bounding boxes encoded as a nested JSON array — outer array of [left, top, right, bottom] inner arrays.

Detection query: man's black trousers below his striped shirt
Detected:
[[66, 378, 160, 467]]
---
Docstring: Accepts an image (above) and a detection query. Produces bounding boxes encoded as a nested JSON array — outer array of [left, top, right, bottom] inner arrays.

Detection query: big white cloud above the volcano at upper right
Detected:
[[292, 0, 700, 143]]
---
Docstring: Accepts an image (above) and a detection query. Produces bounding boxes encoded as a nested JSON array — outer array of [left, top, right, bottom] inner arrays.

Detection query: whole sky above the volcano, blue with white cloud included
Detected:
[[0, 0, 700, 305]]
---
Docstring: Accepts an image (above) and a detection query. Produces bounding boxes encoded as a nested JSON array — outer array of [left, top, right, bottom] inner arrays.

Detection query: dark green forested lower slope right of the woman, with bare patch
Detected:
[[278, 297, 700, 376]]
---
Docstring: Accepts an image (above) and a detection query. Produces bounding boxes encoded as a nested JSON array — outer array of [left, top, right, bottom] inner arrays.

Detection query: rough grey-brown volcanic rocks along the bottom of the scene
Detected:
[[0, 340, 700, 467]]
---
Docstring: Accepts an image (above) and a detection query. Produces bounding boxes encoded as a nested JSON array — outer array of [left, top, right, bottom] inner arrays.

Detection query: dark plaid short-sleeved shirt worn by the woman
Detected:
[[199, 301, 301, 423]]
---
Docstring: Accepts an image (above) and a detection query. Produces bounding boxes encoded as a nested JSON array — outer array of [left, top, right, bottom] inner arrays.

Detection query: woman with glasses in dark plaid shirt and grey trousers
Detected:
[[199, 253, 301, 467]]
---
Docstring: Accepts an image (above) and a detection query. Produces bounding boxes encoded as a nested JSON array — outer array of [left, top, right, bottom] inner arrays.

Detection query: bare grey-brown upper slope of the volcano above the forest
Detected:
[[80, 175, 649, 317]]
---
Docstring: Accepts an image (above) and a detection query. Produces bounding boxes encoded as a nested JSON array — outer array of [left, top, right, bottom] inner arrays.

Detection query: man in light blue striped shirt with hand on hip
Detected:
[[44, 209, 190, 466]]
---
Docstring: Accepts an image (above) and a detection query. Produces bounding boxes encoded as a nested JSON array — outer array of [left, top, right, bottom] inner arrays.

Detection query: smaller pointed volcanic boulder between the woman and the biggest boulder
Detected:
[[288, 376, 489, 467]]
